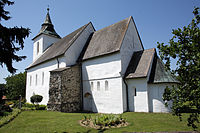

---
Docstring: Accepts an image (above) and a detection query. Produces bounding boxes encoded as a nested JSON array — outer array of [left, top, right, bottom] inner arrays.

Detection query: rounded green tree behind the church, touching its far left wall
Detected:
[[5, 72, 26, 100]]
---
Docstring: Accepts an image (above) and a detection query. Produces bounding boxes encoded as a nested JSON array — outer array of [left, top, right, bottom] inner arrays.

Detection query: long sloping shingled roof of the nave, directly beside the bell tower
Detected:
[[27, 23, 89, 69]]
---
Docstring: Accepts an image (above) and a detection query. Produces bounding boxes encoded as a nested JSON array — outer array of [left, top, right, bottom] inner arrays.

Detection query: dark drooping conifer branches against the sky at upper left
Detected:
[[0, 0, 30, 73]]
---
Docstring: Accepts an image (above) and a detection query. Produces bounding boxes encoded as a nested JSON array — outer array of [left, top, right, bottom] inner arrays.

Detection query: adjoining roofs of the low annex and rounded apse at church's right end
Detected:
[[125, 48, 179, 83]]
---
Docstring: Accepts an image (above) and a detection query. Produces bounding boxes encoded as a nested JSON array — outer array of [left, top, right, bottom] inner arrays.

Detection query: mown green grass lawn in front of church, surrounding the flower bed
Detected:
[[0, 111, 200, 133]]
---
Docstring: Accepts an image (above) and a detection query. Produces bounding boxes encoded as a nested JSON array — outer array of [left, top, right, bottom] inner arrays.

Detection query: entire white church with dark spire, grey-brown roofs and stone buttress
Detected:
[[26, 9, 178, 113]]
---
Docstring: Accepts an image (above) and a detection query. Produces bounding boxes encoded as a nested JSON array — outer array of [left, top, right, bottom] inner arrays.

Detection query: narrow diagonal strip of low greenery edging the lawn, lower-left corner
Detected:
[[0, 109, 21, 127]]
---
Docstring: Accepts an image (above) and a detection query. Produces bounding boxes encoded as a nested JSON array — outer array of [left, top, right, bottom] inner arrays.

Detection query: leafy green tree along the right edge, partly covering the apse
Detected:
[[158, 8, 200, 128]]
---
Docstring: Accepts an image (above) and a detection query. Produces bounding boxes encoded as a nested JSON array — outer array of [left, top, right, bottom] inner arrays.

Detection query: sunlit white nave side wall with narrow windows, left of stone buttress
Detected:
[[26, 56, 66, 105]]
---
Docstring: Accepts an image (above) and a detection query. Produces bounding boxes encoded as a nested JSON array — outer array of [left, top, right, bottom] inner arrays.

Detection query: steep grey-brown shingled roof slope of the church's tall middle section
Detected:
[[83, 17, 131, 60]]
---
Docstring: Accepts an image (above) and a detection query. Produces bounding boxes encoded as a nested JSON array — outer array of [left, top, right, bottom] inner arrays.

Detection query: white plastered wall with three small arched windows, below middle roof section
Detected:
[[82, 53, 123, 113]]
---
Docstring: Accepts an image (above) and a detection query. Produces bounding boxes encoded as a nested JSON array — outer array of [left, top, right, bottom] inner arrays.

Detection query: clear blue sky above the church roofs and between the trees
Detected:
[[0, 0, 200, 83]]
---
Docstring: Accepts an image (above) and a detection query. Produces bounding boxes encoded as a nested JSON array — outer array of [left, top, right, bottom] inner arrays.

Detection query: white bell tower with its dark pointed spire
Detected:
[[32, 8, 61, 61]]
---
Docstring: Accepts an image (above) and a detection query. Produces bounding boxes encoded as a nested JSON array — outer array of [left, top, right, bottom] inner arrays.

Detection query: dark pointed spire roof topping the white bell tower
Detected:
[[33, 8, 61, 40]]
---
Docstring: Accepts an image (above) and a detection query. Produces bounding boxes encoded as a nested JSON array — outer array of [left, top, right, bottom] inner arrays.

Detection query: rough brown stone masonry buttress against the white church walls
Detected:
[[47, 65, 82, 112]]
